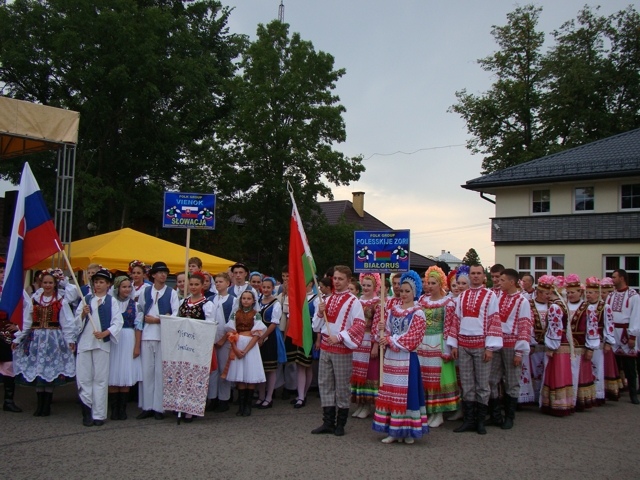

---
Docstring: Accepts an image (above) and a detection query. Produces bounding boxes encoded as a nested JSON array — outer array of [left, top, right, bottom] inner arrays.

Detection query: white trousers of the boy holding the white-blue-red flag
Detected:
[[76, 348, 109, 420]]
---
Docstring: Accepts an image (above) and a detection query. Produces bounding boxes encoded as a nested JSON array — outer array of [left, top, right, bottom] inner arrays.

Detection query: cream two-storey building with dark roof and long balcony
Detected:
[[463, 129, 640, 289]]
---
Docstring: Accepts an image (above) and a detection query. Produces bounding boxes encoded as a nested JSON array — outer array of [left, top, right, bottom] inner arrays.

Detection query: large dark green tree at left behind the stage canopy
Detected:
[[0, 0, 243, 236]]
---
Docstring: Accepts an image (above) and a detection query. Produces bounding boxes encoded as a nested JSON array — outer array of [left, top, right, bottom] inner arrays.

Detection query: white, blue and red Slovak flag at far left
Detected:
[[0, 162, 62, 328]]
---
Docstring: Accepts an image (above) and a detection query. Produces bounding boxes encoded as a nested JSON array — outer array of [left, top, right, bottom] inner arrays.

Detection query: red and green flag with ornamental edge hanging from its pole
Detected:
[[287, 192, 316, 355]]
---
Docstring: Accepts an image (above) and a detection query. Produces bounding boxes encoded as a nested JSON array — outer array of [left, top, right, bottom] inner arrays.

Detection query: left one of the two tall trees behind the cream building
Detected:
[[449, 5, 547, 173]]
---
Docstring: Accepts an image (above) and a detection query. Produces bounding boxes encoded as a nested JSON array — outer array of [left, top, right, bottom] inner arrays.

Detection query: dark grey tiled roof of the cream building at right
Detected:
[[462, 129, 640, 192]]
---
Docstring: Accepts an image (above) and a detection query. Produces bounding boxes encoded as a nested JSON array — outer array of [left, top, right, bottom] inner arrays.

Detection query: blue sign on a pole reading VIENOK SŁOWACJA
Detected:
[[162, 192, 216, 230]]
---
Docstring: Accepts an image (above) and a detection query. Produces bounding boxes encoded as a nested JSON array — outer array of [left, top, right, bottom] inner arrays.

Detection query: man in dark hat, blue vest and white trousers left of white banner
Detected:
[[136, 262, 180, 420]]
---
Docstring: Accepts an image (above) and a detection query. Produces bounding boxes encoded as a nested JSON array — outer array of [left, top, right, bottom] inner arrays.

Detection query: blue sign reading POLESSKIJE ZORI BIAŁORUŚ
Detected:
[[353, 230, 410, 273]]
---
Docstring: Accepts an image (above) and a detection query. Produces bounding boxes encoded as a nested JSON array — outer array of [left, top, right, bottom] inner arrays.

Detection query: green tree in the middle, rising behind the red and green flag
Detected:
[[205, 21, 364, 272]]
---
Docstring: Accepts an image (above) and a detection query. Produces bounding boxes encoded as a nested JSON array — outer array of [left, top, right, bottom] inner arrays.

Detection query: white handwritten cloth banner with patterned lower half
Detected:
[[160, 315, 217, 417]]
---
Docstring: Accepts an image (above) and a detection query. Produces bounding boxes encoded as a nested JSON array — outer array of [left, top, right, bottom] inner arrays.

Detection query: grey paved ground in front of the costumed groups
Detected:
[[0, 385, 640, 480]]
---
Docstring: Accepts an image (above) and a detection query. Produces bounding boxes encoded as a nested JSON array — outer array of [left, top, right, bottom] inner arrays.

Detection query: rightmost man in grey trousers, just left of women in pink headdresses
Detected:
[[489, 268, 531, 430]]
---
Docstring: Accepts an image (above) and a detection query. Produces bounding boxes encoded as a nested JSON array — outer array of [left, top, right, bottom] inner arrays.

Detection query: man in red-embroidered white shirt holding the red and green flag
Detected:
[[311, 265, 365, 436]]
